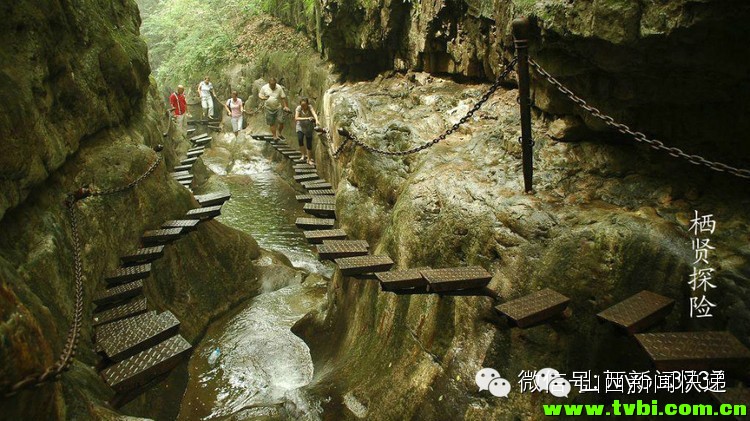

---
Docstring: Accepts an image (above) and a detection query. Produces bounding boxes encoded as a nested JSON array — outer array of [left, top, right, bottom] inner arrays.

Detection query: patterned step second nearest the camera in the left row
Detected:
[[97, 311, 180, 361]]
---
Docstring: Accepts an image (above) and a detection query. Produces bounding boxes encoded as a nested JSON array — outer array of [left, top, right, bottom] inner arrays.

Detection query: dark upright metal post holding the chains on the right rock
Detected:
[[513, 18, 534, 193]]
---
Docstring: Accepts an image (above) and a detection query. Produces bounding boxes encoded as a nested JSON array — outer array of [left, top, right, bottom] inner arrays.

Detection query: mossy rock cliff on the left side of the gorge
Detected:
[[0, 0, 268, 420]]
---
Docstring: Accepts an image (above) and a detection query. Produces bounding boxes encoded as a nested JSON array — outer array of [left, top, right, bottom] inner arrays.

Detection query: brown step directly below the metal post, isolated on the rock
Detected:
[[495, 288, 570, 328]]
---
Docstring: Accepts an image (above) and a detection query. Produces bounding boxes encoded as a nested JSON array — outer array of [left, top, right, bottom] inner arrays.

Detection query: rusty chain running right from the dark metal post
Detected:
[[529, 58, 750, 179]]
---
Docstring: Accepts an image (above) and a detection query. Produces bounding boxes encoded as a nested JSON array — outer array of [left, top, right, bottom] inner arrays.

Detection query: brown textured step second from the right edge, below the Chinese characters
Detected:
[[596, 290, 674, 334]]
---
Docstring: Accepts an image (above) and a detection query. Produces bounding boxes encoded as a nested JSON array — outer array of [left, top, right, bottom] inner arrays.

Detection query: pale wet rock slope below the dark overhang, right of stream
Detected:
[[297, 74, 750, 419]]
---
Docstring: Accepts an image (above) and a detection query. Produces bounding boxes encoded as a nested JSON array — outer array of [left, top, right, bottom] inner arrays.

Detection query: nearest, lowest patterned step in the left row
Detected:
[[102, 335, 191, 393]]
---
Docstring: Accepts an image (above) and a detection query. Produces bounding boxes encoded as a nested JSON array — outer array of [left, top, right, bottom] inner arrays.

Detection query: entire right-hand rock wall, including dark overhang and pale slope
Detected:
[[274, 0, 750, 420]]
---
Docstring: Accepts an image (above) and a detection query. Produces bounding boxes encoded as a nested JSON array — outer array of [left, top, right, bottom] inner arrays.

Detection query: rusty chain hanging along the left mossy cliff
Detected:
[[0, 145, 163, 398]]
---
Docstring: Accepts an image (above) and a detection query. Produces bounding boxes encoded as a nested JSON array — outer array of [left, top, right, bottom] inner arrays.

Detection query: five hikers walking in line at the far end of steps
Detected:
[[169, 76, 320, 164]]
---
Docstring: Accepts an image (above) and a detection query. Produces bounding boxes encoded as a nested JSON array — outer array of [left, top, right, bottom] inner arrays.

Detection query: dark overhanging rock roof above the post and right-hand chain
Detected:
[[310, 0, 750, 166]]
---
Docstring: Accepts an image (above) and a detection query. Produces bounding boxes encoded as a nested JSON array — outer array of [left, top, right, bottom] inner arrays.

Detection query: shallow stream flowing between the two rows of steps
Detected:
[[179, 133, 332, 420]]
